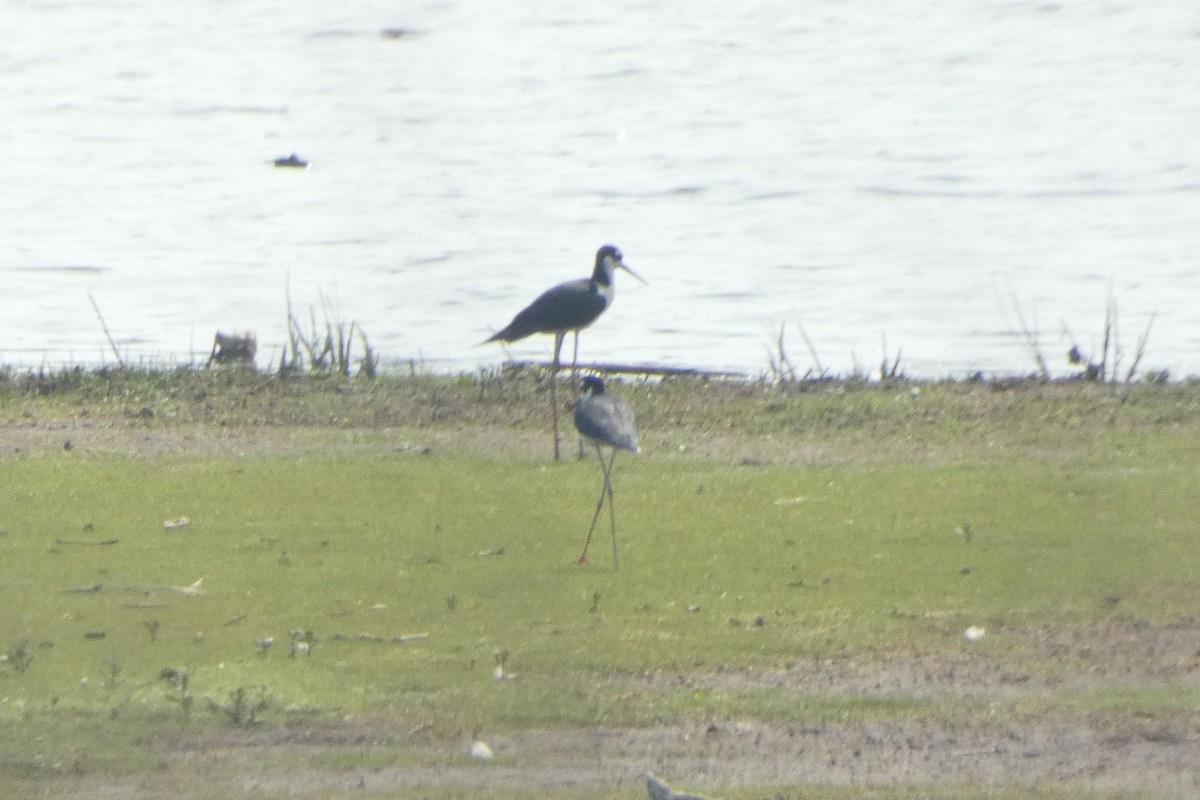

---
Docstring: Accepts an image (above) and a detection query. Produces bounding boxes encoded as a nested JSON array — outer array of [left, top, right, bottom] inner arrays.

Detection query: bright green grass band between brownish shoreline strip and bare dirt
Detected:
[[0, 452, 1196, 705]]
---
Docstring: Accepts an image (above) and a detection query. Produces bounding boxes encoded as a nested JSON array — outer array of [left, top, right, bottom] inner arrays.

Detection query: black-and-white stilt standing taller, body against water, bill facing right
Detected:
[[484, 245, 646, 461]]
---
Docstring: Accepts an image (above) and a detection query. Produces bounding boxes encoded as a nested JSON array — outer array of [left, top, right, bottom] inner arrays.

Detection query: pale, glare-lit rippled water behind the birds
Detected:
[[0, 0, 1200, 377]]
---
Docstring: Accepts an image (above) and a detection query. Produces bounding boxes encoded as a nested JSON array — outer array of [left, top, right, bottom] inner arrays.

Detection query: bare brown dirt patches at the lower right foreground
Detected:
[[72, 620, 1180, 798]]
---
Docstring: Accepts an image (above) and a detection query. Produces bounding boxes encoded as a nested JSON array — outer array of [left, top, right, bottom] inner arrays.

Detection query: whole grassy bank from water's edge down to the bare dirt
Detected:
[[0, 373, 1200, 798]]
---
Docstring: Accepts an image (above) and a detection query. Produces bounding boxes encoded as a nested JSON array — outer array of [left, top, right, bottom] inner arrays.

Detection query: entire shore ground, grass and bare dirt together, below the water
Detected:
[[0, 369, 1200, 799]]
